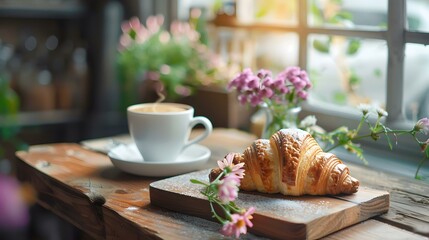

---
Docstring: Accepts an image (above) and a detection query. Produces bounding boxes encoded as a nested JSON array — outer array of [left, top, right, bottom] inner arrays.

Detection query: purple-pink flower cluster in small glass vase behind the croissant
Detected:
[[228, 67, 312, 138]]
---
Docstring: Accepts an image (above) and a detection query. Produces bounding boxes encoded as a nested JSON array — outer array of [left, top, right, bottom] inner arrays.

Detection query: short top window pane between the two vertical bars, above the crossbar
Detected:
[[308, 0, 387, 29]]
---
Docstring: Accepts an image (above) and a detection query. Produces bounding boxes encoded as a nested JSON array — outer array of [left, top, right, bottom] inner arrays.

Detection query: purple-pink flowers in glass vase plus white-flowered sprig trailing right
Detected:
[[228, 67, 429, 178]]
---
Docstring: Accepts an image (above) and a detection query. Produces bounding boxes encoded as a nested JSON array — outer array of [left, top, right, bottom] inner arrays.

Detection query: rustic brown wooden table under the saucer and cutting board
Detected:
[[16, 129, 429, 239]]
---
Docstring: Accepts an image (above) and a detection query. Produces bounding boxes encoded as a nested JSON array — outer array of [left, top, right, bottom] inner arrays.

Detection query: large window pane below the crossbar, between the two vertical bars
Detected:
[[308, 35, 387, 107]]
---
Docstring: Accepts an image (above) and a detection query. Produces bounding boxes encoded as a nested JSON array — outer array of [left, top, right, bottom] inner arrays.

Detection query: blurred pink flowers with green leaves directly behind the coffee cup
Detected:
[[117, 15, 228, 110]]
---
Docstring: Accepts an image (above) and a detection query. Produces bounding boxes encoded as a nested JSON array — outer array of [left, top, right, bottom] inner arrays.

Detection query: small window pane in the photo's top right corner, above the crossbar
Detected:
[[407, 0, 429, 32]]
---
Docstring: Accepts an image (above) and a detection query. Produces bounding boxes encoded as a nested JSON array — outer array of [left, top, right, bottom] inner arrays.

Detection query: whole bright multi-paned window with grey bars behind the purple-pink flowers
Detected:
[[179, 0, 429, 178]]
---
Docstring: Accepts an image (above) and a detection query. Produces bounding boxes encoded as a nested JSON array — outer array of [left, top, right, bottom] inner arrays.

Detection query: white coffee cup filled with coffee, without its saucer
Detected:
[[127, 103, 213, 162]]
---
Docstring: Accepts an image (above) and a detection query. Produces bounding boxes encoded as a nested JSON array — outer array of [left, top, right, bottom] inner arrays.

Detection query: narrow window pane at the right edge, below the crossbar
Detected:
[[404, 43, 429, 121]]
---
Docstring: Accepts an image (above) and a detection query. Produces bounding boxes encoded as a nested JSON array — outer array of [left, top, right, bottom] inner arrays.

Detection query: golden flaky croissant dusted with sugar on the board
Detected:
[[209, 129, 359, 196]]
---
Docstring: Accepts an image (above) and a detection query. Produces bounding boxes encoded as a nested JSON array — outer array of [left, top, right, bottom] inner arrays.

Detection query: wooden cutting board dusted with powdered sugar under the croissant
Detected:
[[150, 170, 389, 239]]
